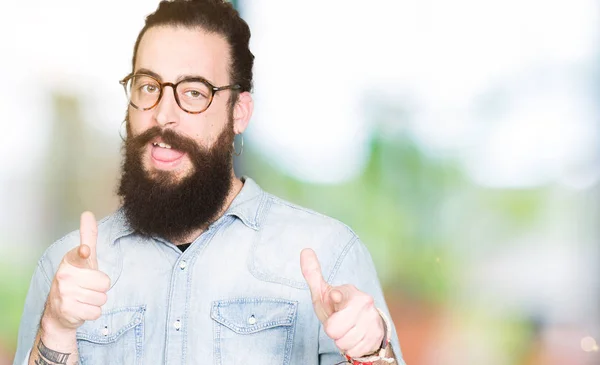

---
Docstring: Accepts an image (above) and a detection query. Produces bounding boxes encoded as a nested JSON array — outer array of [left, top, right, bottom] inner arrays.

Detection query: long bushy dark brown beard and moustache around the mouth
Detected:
[[118, 116, 235, 242]]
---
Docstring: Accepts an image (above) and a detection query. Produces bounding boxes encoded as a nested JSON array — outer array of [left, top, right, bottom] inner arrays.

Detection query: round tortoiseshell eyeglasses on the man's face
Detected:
[[119, 74, 241, 114]]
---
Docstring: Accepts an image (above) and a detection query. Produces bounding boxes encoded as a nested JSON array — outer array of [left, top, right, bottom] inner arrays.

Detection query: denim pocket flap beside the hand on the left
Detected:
[[77, 306, 146, 344]]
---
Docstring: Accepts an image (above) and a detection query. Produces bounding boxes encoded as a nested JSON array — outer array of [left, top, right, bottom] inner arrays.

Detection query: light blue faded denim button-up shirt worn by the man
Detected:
[[14, 178, 404, 365]]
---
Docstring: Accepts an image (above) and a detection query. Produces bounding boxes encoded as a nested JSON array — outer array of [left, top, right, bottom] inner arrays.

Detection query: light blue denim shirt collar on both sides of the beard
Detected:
[[110, 176, 267, 243]]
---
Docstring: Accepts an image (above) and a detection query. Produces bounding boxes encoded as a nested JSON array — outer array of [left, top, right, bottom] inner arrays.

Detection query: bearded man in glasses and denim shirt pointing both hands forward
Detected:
[[15, 0, 403, 365]]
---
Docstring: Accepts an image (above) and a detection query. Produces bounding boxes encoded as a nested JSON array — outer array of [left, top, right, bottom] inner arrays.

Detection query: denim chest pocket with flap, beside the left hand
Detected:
[[77, 306, 146, 365]]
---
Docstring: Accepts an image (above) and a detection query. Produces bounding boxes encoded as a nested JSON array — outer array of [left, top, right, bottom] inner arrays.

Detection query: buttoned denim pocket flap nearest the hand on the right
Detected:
[[210, 298, 298, 334]]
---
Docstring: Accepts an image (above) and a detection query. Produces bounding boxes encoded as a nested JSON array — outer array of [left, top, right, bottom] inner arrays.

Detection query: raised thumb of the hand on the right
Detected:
[[300, 248, 332, 322]]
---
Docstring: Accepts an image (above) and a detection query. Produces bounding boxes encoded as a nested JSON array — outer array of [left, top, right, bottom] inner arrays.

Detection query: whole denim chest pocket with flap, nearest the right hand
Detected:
[[211, 298, 298, 365]]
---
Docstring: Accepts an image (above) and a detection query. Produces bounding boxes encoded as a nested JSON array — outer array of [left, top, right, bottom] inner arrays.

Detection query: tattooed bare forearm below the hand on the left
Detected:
[[28, 320, 79, 365]]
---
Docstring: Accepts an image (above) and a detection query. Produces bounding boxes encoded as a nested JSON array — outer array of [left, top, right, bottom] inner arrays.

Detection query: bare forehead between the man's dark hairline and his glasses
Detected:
[[134, 26, 229, 85]]
